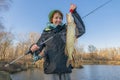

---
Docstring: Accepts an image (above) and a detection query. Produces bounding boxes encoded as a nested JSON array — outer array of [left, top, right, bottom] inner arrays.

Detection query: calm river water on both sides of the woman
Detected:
[[11, 65, 120, 80]]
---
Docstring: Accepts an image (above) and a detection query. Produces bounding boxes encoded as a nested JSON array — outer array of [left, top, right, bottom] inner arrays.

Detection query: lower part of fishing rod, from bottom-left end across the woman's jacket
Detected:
[[4, 35, 55, 67]]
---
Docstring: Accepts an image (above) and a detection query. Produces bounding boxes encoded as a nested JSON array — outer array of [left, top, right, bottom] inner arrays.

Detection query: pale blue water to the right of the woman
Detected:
[[73, 65, 120, 80]]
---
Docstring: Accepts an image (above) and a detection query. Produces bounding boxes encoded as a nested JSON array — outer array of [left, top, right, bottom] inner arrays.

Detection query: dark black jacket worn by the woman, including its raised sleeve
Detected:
[[37, 11, 85, 74]]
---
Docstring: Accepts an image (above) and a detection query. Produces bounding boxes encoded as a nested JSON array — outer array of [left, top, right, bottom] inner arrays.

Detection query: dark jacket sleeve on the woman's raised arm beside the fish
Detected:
[[72, 10, 85, 38]]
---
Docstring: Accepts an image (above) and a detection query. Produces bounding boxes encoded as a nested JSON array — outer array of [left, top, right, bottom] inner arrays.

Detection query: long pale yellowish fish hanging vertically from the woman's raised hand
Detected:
[[65, 13, 76, 67]]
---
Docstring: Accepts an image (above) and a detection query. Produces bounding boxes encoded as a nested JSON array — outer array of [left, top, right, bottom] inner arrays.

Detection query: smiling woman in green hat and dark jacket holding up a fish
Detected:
[[31, 4, 85, 80]]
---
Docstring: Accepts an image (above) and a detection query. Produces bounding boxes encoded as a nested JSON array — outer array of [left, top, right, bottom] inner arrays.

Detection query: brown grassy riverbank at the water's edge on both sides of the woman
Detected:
[[0, 60, 120, 74]]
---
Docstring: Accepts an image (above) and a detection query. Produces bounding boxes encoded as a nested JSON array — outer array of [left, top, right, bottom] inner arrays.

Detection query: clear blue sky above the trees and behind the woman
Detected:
[[4, 0, 120, 48]]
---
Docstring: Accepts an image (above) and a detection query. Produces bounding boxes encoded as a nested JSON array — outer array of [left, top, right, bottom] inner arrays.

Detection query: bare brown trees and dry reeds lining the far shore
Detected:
[[0, 31, 120, 66]]
